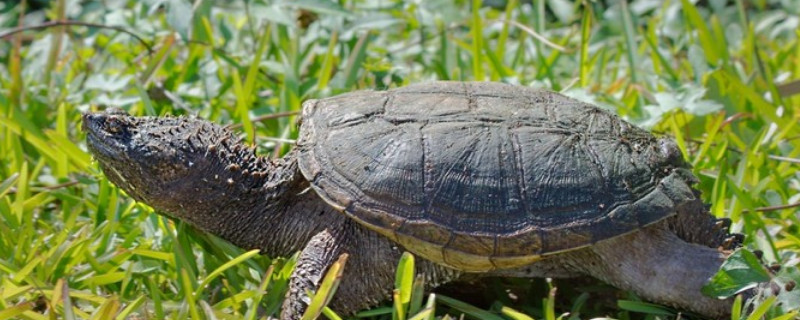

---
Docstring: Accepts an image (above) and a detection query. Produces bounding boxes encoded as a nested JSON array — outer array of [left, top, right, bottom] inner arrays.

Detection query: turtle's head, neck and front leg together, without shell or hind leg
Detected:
[[83, 110, 460, 319]]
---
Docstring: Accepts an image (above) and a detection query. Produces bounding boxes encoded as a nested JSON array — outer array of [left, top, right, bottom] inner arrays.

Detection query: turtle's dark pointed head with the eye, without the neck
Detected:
[[83, 109, 236, 214]]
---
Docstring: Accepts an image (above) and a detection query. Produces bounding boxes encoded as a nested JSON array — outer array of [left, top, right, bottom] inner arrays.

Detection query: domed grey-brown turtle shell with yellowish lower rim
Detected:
[[297, 82, 694, 271]]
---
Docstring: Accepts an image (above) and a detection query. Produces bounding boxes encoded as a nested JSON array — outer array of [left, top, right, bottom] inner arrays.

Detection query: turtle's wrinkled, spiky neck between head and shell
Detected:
[[140, 140, 344, 256]]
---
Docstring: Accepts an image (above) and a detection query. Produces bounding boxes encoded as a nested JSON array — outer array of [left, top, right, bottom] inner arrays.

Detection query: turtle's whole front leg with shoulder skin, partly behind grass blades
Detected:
[[281, 220, 461, 320]]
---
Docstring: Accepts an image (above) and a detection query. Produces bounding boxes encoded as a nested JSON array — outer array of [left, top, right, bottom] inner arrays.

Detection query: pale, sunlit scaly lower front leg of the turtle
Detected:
[[281, 229, 342, 320]]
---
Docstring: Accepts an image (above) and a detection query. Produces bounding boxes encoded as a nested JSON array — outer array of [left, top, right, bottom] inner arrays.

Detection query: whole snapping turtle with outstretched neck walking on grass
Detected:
[[83, 82, 733, 319]]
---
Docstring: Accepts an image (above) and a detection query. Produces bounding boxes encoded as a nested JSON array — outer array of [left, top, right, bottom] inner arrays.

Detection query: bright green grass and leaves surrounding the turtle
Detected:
[[0, 0, 800, 320]]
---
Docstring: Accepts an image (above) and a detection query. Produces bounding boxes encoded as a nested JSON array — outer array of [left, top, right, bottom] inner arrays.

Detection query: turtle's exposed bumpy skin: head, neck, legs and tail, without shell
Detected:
[[83, 83, 731, 319]]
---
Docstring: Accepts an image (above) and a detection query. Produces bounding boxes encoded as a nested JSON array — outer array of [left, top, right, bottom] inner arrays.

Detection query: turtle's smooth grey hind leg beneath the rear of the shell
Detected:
[[565, 225, 732, 318]]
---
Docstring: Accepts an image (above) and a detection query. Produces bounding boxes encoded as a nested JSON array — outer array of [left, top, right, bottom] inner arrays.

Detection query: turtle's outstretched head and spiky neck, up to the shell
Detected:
[[82, 109, 307, 252]]
